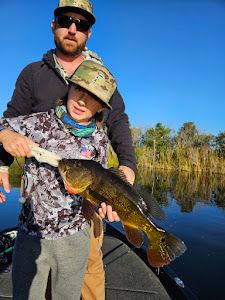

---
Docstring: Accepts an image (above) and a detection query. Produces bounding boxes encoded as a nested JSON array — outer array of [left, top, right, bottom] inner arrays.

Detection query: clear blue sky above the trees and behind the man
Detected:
[[0, 0, 225, 135]]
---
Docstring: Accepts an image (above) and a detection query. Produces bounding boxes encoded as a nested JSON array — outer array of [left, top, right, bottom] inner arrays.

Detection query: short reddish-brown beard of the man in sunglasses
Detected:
[[54, 35, 87, 57]]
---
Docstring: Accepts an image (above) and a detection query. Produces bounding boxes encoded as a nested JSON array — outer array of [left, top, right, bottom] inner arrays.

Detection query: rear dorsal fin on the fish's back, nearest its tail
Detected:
[[138, 190, 166, 220]]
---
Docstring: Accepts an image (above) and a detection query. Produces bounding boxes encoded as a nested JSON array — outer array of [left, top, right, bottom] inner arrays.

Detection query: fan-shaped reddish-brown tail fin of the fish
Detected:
[[147, 230, 187, 268]]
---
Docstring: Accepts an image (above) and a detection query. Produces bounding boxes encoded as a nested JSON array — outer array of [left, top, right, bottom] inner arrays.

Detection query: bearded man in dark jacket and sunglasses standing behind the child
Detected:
[[0, 0, 136, 300]]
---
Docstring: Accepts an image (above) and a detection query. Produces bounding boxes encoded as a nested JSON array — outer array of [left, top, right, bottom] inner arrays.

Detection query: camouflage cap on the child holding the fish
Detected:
[[70, 60, 116, 109]]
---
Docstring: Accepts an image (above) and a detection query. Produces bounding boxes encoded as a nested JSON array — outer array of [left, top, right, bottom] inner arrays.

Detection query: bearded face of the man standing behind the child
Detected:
[[52, 12, 91, 56]]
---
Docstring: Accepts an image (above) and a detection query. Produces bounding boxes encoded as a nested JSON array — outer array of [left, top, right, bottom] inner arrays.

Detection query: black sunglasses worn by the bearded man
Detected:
[[55, 15, 91, 32]]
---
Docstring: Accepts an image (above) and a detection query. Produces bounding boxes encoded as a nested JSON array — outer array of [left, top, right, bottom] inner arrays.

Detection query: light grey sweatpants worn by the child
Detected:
[[12, 226, 90, 300]]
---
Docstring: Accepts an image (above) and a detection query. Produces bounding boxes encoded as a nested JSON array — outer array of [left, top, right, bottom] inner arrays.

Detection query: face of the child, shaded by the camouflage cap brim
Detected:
[[67, 86, 103, 125]]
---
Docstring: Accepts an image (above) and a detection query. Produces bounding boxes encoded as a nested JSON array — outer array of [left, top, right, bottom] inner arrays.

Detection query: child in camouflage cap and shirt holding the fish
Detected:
[[0, 60, 116, 300]]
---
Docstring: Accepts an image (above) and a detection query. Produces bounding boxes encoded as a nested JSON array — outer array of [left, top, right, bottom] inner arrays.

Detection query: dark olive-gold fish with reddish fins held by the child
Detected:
[[58, 159, 187, 268]]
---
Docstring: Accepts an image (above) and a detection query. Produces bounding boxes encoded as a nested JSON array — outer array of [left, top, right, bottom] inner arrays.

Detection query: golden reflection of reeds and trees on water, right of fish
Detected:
[[137, 170, 225, 212]]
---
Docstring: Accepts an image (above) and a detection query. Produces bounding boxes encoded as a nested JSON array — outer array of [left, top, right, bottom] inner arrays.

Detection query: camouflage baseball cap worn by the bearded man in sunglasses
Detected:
[[54, 0, 95, 25]]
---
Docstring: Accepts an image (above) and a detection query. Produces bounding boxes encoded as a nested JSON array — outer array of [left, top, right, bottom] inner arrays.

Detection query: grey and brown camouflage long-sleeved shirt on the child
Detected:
[[0, 110, 108, 240]]
